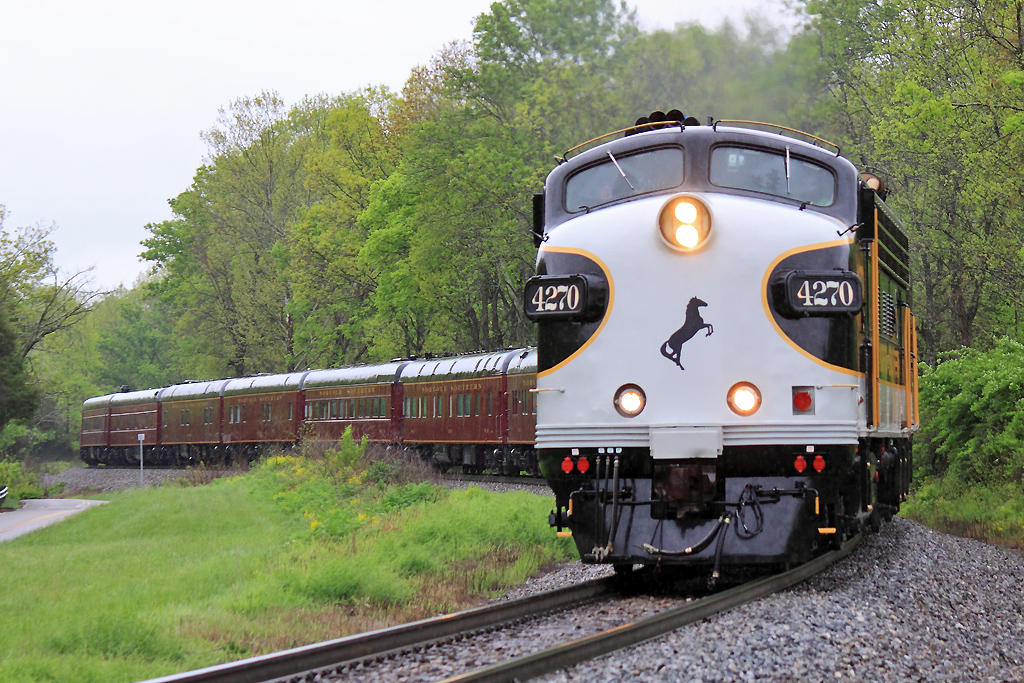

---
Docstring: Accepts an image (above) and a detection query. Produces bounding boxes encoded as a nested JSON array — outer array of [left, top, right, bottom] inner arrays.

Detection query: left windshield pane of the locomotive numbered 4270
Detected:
[[565, 146, 683, 212]]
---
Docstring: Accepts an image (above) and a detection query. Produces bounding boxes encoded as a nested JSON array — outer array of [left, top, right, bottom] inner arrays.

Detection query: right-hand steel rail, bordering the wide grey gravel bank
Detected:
[[442, 535, 860, 683]]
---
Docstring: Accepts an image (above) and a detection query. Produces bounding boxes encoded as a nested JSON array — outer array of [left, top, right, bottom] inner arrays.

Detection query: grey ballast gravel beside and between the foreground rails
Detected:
[[316, 517, 1024, 683]]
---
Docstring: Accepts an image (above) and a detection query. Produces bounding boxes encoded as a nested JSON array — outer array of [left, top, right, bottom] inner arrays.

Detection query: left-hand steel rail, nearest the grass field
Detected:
[[139, 578, 615, 683]]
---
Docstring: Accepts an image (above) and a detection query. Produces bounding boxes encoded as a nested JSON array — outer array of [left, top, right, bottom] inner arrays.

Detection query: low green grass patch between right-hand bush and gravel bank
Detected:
[[900, 474, 1024, 548]]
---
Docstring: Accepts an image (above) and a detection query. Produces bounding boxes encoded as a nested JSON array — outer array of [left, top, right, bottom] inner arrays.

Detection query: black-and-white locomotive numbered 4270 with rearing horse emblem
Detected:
[[524, 110, 919, 580]]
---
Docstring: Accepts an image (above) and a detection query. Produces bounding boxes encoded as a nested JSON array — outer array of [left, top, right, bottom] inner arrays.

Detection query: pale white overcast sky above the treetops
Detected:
[[0, 0, 784, 289]]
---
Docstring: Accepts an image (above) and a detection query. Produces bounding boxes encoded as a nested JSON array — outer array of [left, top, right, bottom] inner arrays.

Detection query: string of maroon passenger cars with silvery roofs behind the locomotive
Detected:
[[80, 348, 538, 474]]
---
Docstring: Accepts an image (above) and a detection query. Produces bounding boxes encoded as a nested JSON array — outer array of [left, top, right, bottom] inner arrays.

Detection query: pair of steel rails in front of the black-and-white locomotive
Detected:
[[150, 535, 860, 683]]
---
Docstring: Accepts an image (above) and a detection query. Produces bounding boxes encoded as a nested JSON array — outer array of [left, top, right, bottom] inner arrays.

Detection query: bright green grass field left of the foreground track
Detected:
[[0, 446, 570, 681]]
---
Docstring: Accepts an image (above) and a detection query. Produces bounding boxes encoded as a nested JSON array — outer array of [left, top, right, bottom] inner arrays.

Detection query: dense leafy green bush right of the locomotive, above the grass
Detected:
[[914, 339, 1024, 483]]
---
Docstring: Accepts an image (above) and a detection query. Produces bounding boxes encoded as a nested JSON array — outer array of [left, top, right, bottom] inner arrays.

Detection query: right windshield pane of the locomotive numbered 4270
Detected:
[[711, 146, 836, 206]]
